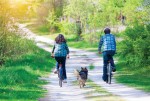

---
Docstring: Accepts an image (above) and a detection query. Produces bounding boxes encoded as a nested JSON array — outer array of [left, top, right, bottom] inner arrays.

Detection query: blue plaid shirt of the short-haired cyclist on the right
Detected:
[[98, 34, 116, 51]]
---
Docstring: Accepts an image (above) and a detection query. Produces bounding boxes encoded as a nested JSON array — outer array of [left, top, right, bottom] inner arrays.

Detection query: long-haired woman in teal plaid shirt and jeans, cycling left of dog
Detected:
[[51, 34, 69, 83]]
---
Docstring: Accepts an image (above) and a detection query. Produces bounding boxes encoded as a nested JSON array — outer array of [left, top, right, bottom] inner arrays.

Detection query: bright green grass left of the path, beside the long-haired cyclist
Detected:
[[0, 43, 54, 101]]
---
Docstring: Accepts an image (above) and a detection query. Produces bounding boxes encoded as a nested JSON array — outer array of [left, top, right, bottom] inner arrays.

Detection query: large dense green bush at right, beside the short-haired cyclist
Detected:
[[118, 25, 150, 68]]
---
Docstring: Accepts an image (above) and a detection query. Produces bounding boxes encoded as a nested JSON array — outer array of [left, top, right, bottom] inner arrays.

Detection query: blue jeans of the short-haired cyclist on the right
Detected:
[[102, 51, 115, 81]]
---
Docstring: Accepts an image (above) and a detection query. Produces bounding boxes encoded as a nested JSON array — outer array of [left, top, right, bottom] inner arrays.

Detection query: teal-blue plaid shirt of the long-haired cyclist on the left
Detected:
[[52, 42, 69, 57]]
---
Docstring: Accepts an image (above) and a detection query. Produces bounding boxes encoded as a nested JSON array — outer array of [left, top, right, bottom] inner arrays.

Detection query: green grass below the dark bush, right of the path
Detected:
[[116, 63, 150, 92]]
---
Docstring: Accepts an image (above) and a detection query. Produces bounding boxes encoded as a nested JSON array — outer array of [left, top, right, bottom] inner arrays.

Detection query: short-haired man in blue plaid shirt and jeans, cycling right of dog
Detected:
[[98, 28, 116, 82]]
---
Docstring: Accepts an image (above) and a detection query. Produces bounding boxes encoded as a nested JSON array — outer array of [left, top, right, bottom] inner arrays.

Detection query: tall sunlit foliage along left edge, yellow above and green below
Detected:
[[0, 0, 36, 65]]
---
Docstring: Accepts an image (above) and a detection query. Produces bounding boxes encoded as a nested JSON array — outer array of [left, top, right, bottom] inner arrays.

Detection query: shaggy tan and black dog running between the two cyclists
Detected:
[[74, 67, 88, 88]]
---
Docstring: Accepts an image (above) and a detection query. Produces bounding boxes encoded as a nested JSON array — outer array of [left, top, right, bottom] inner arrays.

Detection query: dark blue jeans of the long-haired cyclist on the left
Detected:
[[55, 57, 67, 79]]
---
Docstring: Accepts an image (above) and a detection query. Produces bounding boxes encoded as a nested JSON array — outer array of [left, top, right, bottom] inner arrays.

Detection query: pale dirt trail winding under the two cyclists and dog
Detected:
[[19, 25, 150, 101]]
